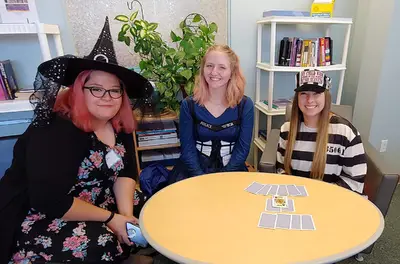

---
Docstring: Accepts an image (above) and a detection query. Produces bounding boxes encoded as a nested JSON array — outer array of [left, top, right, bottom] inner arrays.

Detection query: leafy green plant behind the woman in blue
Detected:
[[115, 11, 218, 113]]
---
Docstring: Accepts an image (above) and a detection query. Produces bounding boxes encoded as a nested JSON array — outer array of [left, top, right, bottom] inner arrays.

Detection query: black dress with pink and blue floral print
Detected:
[[9, 134, 144, 264]]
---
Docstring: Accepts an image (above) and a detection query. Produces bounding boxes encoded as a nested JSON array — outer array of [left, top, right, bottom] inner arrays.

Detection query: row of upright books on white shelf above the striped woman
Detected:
[[278, 37, 333, 67]]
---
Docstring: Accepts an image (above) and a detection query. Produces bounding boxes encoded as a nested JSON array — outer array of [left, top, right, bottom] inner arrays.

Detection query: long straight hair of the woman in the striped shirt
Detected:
[[284, 90, 332, 180]]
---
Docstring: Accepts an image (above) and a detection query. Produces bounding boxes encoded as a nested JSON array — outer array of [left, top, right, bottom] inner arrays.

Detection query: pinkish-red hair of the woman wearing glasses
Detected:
[[53, 70, 136, 133]]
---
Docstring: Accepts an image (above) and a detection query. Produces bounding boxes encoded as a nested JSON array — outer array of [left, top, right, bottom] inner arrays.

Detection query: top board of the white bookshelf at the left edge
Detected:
[[0, 23, 60, 35]]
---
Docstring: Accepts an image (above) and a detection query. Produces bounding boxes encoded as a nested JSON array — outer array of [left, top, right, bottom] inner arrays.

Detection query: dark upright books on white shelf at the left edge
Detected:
[[0, 60, 18, 101]]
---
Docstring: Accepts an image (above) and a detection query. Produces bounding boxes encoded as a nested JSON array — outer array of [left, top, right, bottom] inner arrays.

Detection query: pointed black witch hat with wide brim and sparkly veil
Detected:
[[30, 17, 153, 126]]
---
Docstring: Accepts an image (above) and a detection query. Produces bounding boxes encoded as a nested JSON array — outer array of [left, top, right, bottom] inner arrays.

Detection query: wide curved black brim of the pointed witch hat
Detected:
[[38, 57, 153, 99]]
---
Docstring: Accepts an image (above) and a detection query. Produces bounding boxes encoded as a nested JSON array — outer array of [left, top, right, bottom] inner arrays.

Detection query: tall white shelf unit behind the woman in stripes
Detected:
[[253, 16, 353, 169]]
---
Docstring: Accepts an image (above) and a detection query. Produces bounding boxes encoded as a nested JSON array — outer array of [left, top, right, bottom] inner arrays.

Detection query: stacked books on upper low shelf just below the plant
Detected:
[[136, 120, 179, 147]]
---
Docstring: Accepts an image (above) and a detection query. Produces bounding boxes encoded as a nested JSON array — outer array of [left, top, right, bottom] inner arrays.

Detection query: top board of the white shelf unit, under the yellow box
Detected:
[[257, 16, 353, 25]]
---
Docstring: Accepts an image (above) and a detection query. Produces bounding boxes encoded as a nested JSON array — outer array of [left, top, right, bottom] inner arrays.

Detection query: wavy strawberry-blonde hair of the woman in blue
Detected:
[[193, 45, 246, 107]]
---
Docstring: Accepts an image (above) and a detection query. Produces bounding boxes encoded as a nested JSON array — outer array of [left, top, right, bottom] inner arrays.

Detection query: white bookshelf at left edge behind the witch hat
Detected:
[[0, 23, 64, 114]]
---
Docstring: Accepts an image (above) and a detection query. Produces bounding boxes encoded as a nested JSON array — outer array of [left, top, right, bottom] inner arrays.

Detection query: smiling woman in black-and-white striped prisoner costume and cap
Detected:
[[277, 70, 367, 193]]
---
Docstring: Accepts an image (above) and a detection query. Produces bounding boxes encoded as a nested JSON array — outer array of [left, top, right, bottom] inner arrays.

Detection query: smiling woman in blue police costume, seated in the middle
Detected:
[[170, 45, 254, 182]]
